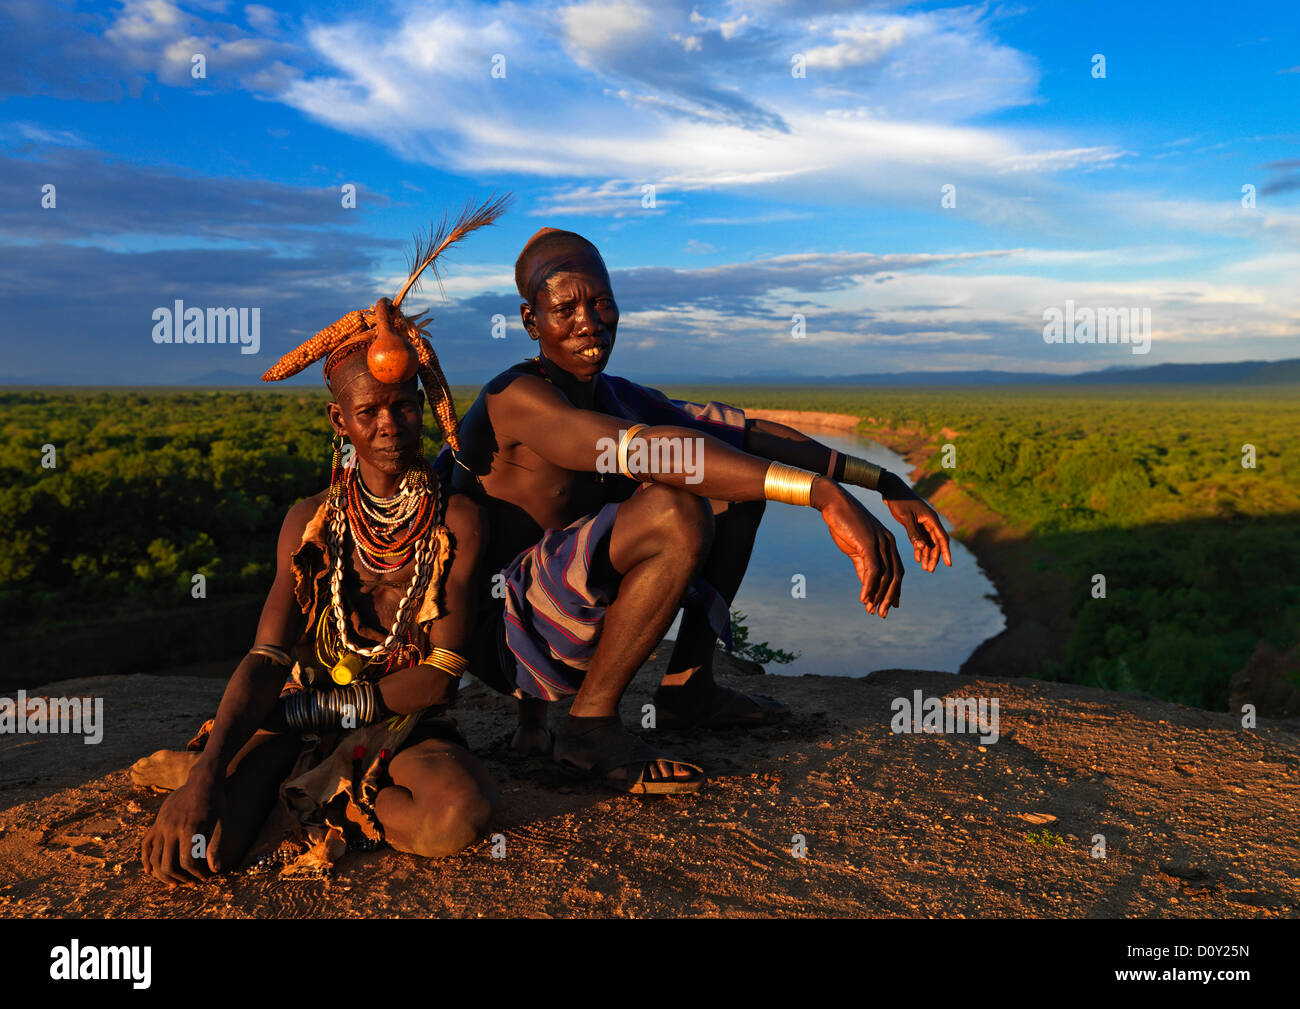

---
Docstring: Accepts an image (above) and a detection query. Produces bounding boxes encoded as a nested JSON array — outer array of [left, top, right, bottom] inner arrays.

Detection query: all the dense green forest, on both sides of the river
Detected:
[[0, 386, 1300, 709]]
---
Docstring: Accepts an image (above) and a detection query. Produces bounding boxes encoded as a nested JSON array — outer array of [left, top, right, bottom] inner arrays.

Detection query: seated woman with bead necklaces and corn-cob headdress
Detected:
[[131, 202, 503, 885]]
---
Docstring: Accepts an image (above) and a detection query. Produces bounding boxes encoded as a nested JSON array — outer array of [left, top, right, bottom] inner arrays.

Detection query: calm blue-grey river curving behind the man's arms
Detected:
[[668, 428, 1006, 676]]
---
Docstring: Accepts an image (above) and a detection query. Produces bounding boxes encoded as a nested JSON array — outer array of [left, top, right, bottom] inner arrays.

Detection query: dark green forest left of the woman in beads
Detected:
[[0, 389, 467, 625]]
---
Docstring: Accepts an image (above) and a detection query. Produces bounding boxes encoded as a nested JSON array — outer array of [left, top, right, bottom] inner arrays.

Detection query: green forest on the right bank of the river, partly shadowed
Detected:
[[691, 385, 1300, 710]]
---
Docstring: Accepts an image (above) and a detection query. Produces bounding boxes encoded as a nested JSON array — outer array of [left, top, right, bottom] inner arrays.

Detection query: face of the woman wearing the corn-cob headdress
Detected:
[[329, 371, 424, 476]]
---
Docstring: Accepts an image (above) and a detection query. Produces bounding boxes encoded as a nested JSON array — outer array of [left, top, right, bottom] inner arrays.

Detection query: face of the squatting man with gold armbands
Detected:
[[521, 252, 619, 382]]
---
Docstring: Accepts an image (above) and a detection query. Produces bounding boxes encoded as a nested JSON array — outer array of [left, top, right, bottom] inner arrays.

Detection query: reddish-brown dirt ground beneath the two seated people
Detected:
[[0, 647, 1300, 918]]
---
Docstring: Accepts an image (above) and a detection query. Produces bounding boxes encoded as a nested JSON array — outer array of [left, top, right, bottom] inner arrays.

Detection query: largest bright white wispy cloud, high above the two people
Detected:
[[271, 0, 1107, 212]]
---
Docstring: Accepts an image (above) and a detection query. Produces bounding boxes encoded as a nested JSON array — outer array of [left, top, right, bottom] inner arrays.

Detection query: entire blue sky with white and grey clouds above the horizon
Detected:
[[0, 0, 1300, 384]]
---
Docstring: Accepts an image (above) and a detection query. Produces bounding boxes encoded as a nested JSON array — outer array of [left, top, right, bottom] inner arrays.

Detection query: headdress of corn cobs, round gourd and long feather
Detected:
[[261, 194, 510, 452]]
